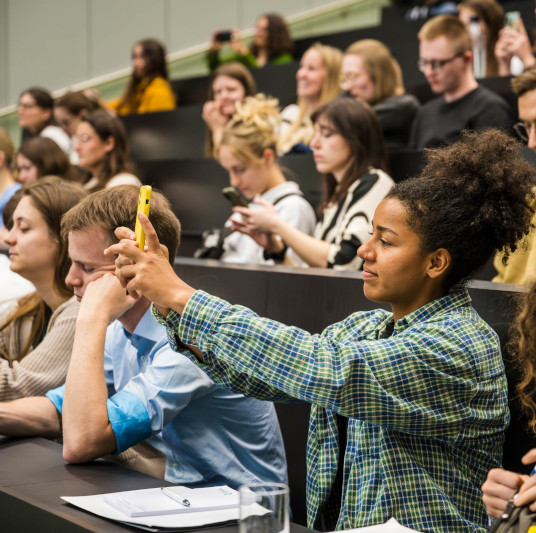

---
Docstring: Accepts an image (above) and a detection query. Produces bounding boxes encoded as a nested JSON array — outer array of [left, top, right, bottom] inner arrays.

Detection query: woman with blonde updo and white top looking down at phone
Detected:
[[196, 94, 316, 264]]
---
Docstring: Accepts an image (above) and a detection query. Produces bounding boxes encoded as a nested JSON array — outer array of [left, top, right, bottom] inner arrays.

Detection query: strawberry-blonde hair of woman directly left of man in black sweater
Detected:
[[344, 39, 405, 105]]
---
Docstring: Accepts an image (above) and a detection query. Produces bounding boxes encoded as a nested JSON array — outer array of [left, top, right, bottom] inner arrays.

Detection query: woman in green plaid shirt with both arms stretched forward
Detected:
[[110, 130, 534, 533]]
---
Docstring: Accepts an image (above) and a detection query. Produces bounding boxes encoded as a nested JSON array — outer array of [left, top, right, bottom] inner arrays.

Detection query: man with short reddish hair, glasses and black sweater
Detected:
[[410, 15, 512, 150]]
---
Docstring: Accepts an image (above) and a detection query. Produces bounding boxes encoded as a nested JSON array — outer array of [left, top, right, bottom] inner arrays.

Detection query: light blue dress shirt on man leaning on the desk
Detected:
[[47, 309, 287, 488]]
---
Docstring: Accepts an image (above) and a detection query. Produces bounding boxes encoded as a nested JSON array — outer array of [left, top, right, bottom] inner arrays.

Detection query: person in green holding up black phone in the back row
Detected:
[[207, 13, 294, 72]]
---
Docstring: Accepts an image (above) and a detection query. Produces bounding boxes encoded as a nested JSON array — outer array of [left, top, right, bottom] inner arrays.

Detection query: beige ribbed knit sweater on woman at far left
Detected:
[[0, 296, 79, 401]]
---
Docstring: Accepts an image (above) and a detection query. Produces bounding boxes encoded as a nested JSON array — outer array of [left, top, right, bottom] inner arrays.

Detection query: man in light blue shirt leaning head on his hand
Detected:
[[0, 186, 286, 488]]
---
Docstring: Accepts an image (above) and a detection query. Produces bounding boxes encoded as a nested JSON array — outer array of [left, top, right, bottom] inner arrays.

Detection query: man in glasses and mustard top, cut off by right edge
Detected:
[[493, 67, 536, 284]]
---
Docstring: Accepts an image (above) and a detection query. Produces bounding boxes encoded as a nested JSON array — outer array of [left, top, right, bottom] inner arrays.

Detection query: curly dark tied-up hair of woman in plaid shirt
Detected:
[[387, 129, 536, 291]]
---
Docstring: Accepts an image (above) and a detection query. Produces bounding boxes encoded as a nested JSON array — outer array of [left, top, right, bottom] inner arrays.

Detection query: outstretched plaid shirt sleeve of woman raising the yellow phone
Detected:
[[171, 291, 504, 441]]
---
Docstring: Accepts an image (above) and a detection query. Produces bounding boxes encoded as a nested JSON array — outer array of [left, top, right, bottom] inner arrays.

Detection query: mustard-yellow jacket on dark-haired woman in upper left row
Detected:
[[108, 78, 176, 115]]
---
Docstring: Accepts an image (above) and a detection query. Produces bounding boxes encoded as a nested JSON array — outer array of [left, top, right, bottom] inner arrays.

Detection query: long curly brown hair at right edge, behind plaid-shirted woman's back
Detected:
[[508, 283, 536, 435]]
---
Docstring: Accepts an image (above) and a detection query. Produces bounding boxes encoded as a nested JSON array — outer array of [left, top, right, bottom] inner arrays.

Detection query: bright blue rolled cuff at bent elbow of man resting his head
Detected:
[[106, 390, 152, 453]]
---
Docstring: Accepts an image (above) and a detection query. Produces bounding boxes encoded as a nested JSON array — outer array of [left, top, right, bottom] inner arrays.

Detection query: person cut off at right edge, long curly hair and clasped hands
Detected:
[[482, 283, 536, 517]]
